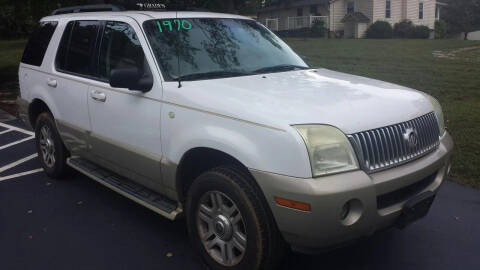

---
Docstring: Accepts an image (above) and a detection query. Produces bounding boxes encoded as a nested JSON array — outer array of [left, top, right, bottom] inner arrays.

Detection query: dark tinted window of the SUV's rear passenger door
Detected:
[[55, 21, 100, 76]]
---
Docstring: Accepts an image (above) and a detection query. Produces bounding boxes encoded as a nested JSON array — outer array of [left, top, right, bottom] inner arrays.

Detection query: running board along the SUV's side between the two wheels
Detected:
[[67, 157, 183, 220]]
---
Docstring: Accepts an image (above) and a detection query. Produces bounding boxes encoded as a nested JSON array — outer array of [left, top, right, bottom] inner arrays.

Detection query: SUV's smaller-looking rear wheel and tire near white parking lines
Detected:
[[35, 112, 71, 179]]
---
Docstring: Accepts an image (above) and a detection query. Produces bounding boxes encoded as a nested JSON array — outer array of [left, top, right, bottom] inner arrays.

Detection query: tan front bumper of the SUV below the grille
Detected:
[[251, 133, 453, 252]]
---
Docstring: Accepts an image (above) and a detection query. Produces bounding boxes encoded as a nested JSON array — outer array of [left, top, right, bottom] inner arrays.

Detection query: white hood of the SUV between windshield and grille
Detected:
[[166, 69, 433, 134]]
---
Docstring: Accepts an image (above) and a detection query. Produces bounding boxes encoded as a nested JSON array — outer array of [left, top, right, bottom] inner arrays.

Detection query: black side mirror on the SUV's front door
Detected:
[[110, 67, 153, 93]]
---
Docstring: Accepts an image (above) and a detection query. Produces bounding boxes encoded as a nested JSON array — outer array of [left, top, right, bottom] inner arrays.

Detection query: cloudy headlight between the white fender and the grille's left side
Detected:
[[294, 125, 358, 177]]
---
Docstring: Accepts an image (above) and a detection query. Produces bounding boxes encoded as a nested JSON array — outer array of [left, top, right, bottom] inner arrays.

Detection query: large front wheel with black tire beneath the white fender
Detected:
[[186, 167, 286, 270]]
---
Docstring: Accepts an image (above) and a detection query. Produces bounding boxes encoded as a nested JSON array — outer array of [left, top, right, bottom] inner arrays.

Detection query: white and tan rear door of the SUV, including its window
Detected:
[[49, 20, 100, 157]]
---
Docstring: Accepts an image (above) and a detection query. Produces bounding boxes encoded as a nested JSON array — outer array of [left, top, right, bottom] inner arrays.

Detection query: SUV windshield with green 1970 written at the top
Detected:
[[143, 18, 308, 81]]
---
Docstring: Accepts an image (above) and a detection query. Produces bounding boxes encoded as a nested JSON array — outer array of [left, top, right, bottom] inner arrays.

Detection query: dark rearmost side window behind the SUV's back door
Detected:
[[22, 22, 57, 66]]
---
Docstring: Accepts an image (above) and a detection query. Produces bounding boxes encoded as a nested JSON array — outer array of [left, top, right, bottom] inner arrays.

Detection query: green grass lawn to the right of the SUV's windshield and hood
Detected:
[[285, 38, 480, 188]]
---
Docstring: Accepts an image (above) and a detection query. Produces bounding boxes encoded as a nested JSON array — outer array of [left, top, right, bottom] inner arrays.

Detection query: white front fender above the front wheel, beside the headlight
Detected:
[[162, 104, 311, 191]]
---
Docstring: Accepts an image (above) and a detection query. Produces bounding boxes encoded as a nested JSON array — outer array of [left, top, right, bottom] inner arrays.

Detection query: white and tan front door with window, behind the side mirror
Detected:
[[88, 20, 162, 192]]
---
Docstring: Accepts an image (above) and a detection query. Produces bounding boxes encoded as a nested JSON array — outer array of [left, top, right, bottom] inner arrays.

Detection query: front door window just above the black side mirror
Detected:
[[99, 22, 150, 80]]
